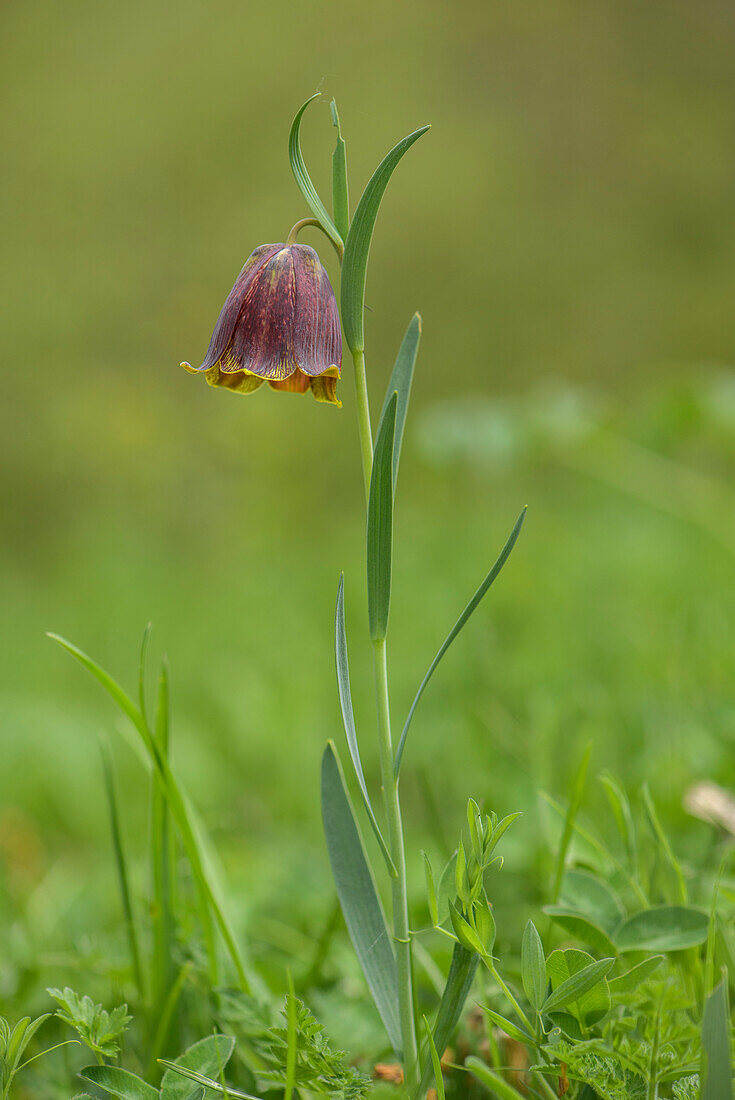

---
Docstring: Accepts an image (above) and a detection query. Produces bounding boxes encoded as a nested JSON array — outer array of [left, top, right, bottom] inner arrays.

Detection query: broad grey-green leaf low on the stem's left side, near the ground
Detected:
[[321, 741, 401, 1055]]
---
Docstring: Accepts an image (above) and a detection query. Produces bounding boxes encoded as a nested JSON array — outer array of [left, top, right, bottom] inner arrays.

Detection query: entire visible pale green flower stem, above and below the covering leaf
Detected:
[[352, 351, 419, 1096]]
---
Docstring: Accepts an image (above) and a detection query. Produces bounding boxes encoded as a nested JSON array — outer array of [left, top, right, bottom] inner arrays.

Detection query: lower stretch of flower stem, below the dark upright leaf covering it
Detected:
[[373, 639, 418, 1096]]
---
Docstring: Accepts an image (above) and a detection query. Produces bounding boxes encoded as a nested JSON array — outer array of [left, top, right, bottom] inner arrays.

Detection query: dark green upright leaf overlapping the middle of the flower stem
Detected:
[[366, 394, 398, 641]]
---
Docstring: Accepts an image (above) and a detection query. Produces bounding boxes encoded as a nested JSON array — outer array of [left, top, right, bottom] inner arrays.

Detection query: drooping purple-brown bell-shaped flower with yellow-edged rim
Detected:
[[182, 244, 342, 405]]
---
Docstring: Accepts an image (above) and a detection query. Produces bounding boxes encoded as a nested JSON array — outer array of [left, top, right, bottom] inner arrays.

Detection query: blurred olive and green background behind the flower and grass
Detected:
[[0, 0, 735, 992]]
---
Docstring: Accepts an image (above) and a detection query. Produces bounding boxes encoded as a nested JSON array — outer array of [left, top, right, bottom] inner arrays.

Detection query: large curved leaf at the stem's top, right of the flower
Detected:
[[341, 127, 429, 354]]
